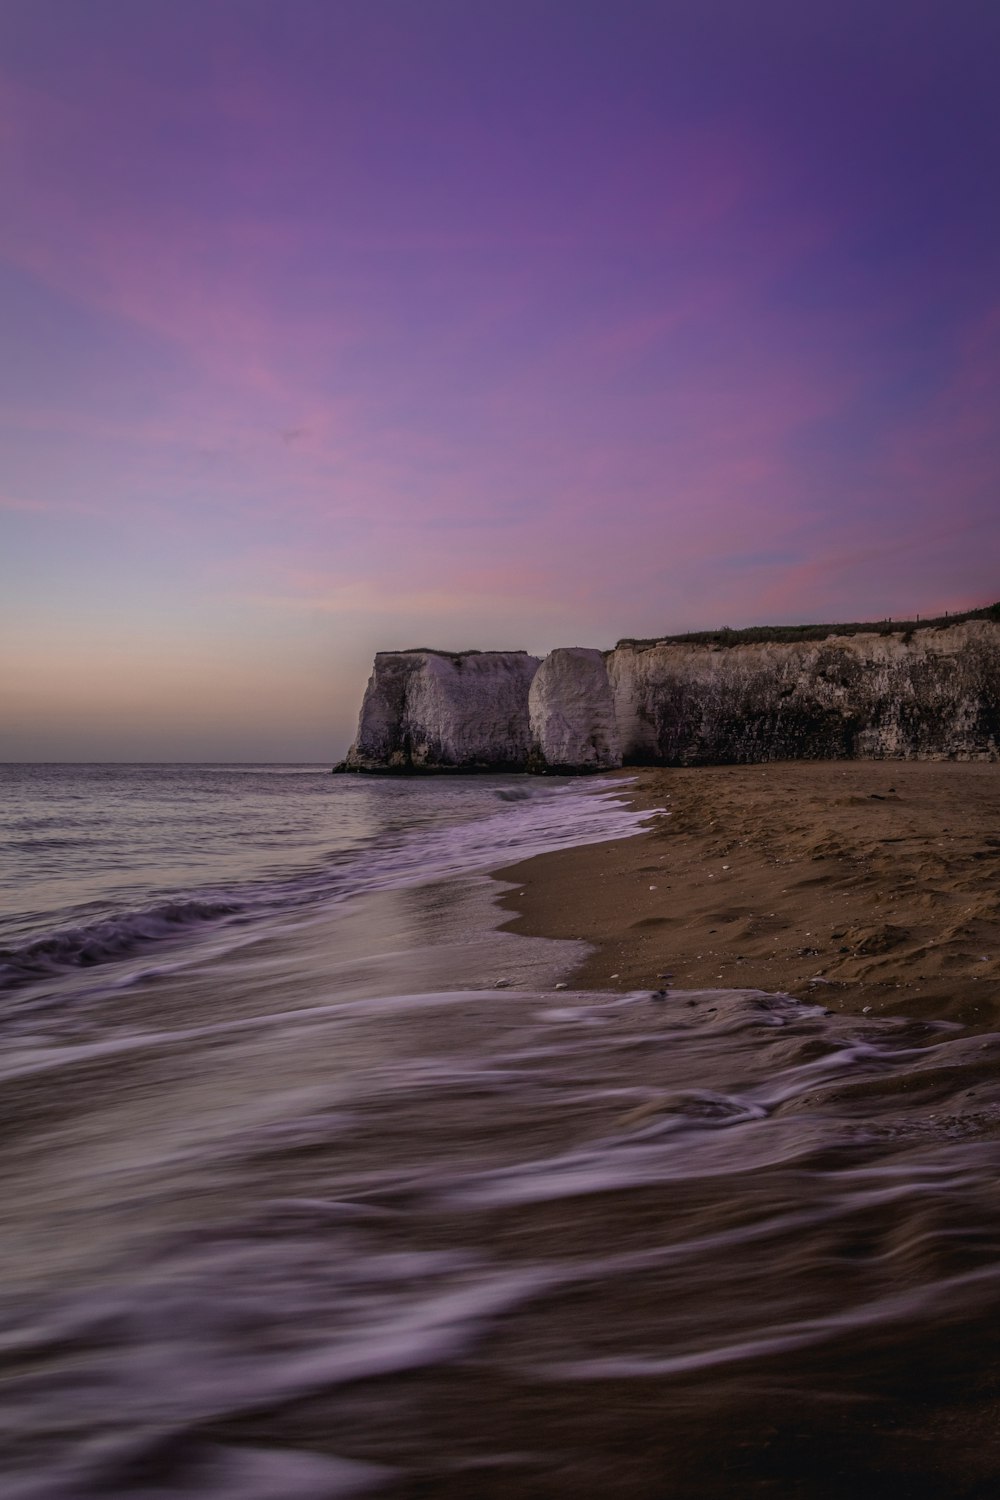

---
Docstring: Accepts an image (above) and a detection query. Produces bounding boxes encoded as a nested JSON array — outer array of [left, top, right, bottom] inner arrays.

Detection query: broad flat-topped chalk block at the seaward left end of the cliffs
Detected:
[[342, 651, 538, 771]]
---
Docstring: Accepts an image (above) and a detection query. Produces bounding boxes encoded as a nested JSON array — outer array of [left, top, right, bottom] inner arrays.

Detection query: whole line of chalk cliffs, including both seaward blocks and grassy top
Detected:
[[340, 611, 1000, 771]]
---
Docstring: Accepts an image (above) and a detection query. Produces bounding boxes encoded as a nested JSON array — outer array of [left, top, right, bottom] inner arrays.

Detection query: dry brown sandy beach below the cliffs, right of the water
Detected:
[[493, 761, 1000, 1029]]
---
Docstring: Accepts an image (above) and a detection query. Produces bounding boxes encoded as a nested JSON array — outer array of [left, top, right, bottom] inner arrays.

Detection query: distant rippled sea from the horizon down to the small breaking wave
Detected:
[[0, 765, 637, 989]]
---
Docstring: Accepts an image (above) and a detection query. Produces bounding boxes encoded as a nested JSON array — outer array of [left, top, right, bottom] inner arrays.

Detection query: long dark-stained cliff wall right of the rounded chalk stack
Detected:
[[607, 621, 1000, 765]]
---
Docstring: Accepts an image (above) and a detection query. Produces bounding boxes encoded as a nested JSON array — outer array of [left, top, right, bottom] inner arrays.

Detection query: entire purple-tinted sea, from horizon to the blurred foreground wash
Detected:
[[0, 765, 1000, 1500]]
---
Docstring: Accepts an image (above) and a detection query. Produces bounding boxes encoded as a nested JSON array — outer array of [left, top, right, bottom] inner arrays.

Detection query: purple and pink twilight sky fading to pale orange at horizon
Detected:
[[0, 0, 1000, 762]]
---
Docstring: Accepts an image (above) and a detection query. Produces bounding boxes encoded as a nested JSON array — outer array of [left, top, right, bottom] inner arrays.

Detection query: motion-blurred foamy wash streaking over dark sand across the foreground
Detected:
[[0, 990, 1000, 1500]]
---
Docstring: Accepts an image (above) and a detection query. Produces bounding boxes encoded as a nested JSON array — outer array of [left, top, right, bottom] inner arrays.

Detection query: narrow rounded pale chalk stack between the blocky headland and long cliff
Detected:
[[528, 647, 622, 773]]
